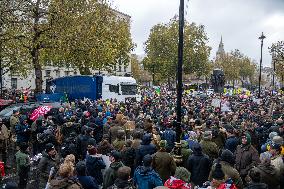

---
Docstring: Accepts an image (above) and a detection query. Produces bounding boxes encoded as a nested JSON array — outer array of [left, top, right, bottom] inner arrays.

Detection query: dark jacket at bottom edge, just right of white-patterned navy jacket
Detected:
[[103, 161, 124, 189]]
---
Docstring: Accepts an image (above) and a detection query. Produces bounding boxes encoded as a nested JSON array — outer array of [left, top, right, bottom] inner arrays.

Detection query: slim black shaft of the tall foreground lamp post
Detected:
[[176, 0, 184, 142]]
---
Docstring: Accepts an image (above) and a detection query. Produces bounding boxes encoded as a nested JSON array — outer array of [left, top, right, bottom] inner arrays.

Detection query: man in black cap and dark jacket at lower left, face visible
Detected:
[[38, 143, 58, 188]]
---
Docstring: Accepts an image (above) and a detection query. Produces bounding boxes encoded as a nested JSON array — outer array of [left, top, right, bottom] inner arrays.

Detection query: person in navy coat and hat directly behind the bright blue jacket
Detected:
[[135, 134, 157, 166]]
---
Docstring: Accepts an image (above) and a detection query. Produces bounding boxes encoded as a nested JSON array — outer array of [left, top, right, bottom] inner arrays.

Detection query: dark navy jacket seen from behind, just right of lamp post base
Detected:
[[186, 150, 211, 186]]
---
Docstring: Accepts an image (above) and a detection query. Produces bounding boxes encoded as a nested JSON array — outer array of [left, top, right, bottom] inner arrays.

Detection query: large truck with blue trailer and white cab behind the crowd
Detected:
[[47, 75, 141, 102]]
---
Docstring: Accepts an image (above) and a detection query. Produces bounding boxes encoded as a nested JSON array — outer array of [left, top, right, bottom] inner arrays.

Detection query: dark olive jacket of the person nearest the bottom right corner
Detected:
[[253, 164, 280, 189]]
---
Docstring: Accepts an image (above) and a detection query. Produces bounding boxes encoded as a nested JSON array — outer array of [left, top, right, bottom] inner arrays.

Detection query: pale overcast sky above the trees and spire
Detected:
[[113, 0, 284, 66]]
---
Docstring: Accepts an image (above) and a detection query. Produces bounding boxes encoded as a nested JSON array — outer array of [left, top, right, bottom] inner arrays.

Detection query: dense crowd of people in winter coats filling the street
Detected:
[[0, 89, 284, 189]]
